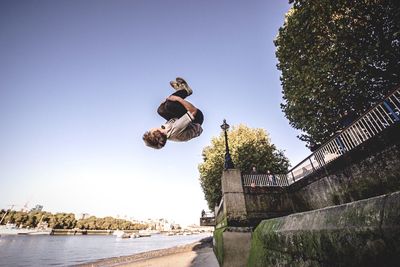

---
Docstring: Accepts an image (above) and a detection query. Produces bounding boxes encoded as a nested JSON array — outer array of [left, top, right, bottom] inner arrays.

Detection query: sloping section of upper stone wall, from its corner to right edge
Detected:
[[288, 124, 400, 212]]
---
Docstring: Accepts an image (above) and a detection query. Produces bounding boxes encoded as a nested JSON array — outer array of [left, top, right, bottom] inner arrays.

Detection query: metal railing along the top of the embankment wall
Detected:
[[242, 87, 400, 186]]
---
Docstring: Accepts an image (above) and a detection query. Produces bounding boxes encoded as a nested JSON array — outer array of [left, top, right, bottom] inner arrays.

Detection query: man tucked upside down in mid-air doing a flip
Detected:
[[143, 77, 204, 149]]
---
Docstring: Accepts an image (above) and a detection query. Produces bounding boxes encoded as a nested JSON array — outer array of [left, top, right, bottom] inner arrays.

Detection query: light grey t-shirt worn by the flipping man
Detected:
[[163, 112, 203, 142]]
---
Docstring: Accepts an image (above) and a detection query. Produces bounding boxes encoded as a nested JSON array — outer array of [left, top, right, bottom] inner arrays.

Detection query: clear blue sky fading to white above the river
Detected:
[[0, 0, 309, 224]]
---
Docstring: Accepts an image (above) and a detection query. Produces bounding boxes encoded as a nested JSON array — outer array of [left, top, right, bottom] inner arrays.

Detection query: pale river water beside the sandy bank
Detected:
[[0, 233, 210, 267]]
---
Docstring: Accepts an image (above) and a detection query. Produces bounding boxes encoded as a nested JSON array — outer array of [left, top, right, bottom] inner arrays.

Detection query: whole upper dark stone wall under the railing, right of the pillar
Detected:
[[243, 124, 400, 225]]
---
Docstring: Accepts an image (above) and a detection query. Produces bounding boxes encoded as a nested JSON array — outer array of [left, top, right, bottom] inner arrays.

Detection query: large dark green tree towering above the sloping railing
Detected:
[[275, 0, 400, 147]]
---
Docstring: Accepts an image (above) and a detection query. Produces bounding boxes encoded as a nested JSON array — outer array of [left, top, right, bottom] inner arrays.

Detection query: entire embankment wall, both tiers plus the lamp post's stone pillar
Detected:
[[214, 124, 400, 266]]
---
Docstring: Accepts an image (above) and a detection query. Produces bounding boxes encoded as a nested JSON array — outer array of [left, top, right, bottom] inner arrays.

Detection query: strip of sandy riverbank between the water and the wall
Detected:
[[79, 237, 219, 267]]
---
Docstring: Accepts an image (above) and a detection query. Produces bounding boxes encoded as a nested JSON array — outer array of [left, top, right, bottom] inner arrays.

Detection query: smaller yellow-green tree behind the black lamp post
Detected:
[[199, 125, 289, 209]]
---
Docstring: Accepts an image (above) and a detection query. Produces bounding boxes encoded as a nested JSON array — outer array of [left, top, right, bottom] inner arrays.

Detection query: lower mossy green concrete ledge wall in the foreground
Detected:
[[248, 192, 400, 266]]
